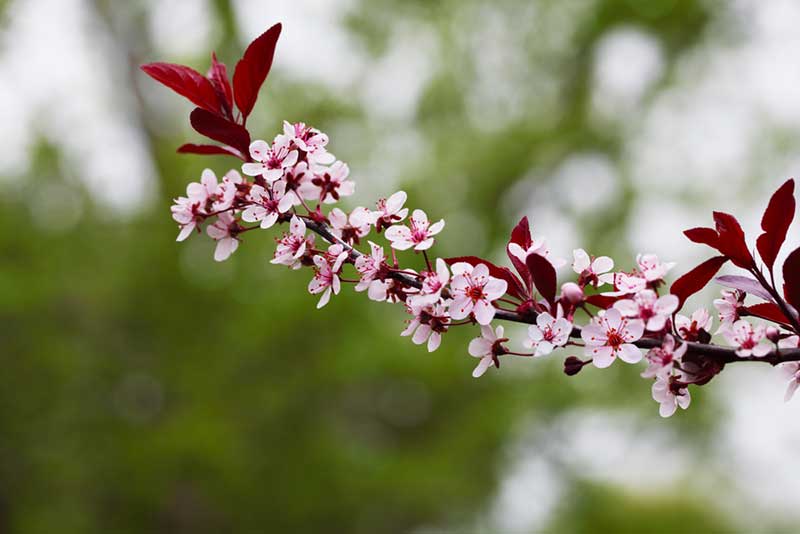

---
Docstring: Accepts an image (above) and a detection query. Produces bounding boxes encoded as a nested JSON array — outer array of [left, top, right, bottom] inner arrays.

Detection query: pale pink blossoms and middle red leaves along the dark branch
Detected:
[[172, 122, 800, 417]]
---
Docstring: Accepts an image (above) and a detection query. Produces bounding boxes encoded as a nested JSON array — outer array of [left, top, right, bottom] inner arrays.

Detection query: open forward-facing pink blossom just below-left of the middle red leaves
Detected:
[[450, 262, 508, 325]]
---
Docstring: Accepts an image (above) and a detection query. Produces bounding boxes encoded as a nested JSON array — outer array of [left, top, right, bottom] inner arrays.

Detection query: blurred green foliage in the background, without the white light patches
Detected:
[[0, 0, 768, 534]]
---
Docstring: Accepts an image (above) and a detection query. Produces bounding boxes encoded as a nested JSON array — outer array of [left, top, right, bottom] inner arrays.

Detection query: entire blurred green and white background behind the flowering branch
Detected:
[[0, 0, 800, 533]]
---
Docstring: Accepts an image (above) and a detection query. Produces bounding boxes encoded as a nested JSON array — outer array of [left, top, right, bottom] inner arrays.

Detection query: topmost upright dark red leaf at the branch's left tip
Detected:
[[233, 23, 281, 122]]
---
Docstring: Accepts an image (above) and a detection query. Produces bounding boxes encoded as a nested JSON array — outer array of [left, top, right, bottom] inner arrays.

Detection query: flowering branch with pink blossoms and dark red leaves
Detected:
[[142, 24, 800, 417]]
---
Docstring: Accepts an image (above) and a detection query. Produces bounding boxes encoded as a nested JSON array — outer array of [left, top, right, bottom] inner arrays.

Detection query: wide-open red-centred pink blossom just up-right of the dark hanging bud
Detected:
[[581, 308, 644, 368]]
